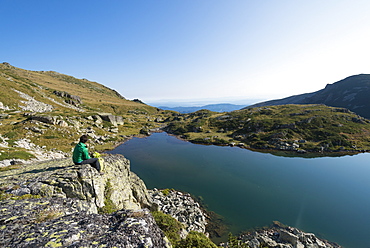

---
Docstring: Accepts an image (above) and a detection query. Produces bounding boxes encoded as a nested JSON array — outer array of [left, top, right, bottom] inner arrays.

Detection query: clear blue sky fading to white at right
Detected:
[[0, 0, 370, 102]]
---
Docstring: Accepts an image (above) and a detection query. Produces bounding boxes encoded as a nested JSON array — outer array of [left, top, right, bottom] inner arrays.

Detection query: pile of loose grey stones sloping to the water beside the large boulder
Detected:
[[149, 189, 207, 236]]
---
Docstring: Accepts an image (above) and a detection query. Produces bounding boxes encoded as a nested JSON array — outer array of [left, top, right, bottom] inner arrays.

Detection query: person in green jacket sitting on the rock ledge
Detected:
[[72, 135, 101, 172]]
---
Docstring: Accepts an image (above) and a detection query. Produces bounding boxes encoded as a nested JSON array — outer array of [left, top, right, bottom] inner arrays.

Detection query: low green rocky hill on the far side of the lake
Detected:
[[166, 104, 370, 153]]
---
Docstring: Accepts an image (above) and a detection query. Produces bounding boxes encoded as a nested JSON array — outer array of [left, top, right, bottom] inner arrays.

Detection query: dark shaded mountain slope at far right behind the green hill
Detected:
[[246, 74, 370, 119]]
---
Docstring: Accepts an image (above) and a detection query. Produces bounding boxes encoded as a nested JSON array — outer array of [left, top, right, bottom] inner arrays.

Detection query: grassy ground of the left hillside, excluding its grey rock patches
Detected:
[[0, 64, 169, 160]]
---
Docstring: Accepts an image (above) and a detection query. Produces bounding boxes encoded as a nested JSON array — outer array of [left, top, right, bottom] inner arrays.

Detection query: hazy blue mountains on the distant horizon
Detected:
[[158, 103, 246, 114]]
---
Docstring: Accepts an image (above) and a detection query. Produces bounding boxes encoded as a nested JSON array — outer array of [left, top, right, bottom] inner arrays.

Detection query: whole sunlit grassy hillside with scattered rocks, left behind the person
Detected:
[[0, 63, 166, 160]]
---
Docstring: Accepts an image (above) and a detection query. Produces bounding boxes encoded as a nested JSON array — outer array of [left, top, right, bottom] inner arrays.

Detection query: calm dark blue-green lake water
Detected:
[[110, 133, 370, 248]]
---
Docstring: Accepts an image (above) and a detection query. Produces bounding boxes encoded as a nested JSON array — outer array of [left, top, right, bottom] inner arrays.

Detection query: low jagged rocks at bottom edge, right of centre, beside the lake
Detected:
[[221, 222, 341, 248]]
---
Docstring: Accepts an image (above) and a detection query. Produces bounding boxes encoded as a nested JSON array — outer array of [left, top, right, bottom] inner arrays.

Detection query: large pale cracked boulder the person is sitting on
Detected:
[[0, 155, 152, 213]]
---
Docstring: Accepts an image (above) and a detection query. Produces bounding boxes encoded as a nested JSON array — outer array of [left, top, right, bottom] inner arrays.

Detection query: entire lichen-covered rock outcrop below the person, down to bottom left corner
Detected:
[[0, 155, 172, 248]]
